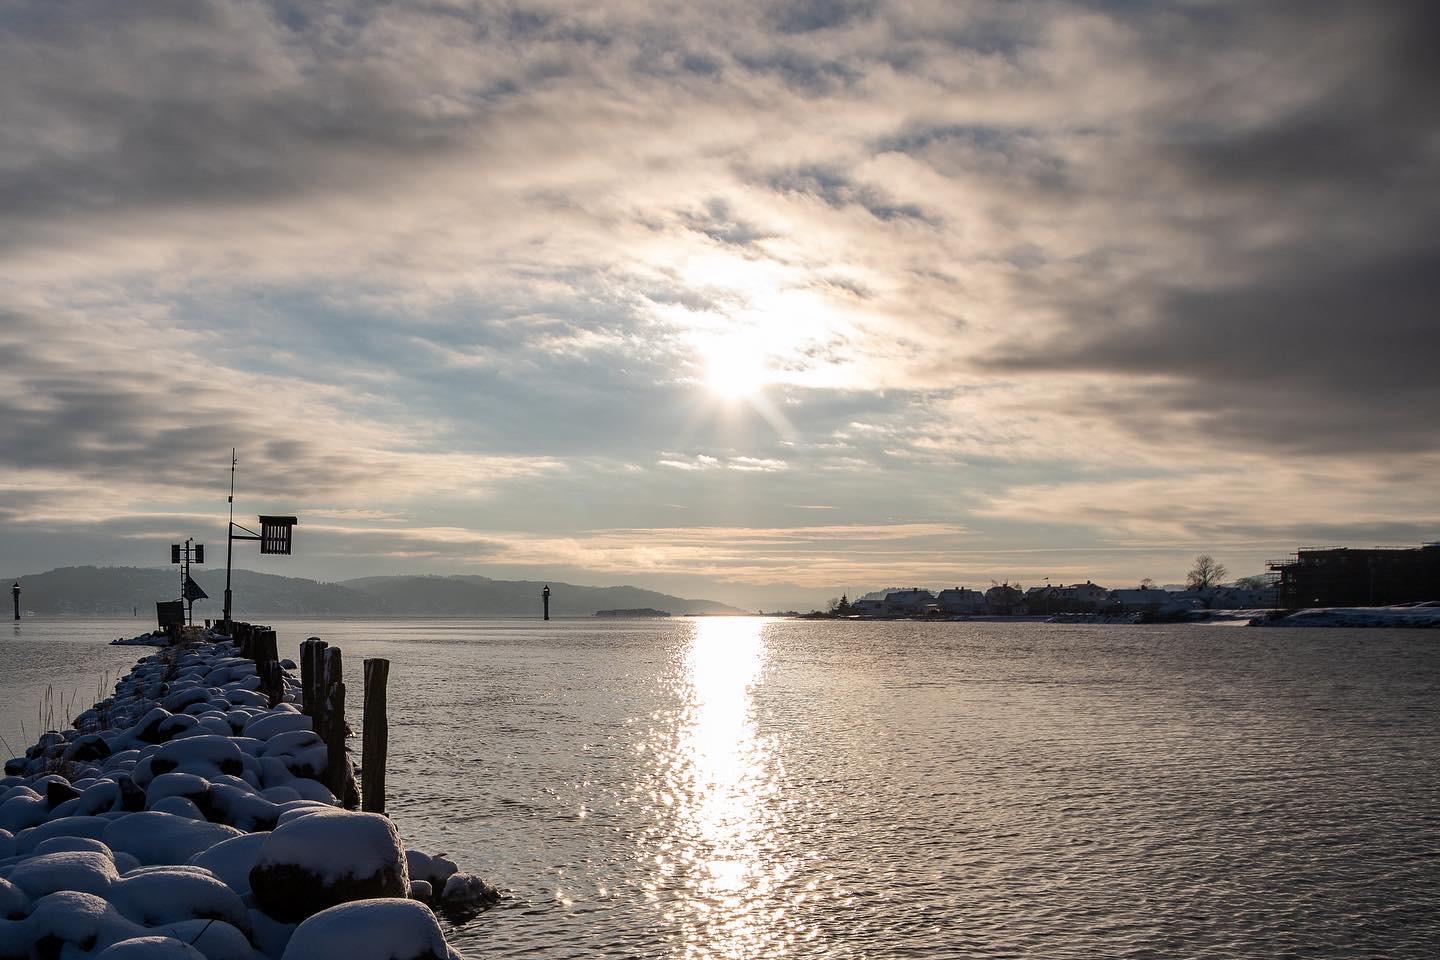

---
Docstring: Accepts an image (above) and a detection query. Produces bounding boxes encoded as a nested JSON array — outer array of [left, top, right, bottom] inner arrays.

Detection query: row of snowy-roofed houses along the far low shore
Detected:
[[848, 580, 1274, 617]]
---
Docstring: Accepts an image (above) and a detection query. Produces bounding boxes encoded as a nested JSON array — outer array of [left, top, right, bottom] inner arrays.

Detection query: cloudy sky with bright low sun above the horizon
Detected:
[[0, 0, 1440, 607]]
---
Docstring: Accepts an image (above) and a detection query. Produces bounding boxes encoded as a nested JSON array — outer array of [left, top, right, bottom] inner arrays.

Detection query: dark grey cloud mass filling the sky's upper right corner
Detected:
[[994, 3, 1440, 455]]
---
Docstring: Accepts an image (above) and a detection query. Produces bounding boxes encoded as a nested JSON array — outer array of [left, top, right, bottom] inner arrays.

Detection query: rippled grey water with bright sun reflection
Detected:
[[0, 619, 1440, 959]]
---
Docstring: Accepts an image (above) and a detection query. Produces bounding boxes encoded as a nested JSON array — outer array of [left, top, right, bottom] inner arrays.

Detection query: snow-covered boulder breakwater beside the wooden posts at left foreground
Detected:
[[0, 640, 498, 960]]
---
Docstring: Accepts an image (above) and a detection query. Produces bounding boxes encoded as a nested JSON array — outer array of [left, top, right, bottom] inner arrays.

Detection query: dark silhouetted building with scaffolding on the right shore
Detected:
[[1267, 543, 1440, 610]]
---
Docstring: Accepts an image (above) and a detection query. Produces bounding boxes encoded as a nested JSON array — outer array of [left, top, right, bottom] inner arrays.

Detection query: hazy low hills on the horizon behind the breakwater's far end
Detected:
[[4, 567, 742, 619]]
